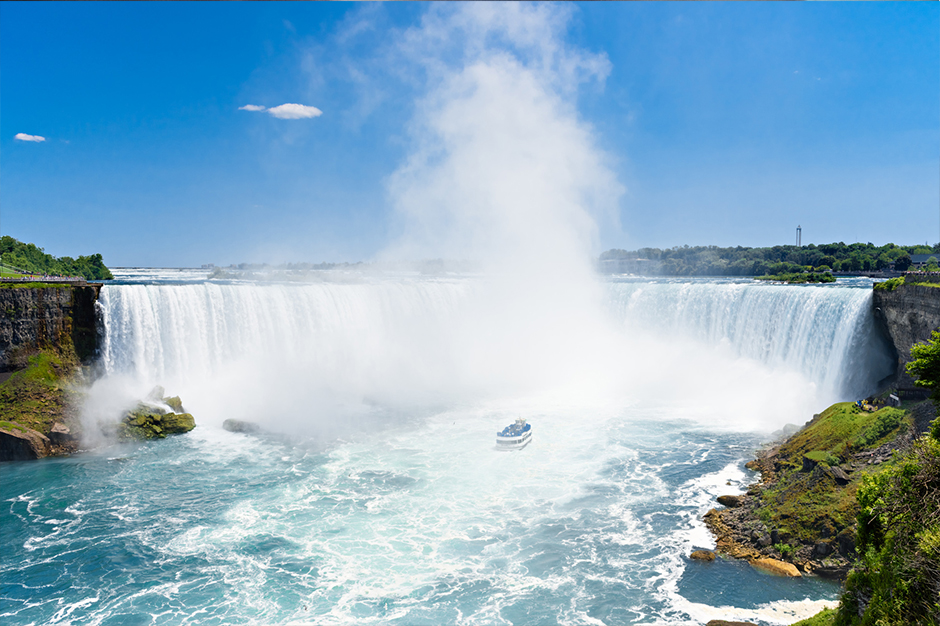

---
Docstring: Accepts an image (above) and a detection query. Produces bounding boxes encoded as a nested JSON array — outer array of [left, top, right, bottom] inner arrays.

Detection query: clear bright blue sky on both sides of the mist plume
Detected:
[[0, 3, 940, 266]]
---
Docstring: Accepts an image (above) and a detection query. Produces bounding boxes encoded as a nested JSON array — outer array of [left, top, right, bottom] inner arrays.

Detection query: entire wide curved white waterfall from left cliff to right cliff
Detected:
[[93, 275, 891, 432]]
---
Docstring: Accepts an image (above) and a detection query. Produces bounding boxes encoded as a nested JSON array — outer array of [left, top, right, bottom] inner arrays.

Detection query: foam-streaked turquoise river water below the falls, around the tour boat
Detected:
[[0, 412, 838, 624]]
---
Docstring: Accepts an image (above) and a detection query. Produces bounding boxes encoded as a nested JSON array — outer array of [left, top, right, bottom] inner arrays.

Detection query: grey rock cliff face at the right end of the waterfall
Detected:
[[873, 283, 940, 392]]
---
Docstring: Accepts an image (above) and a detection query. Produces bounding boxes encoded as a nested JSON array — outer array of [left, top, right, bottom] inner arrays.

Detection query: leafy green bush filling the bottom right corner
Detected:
[[836, 436, 940, 626]]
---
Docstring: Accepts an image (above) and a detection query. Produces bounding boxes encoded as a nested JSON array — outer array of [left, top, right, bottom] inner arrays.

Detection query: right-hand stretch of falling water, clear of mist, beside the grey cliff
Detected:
[[610, 281, 892, 399]]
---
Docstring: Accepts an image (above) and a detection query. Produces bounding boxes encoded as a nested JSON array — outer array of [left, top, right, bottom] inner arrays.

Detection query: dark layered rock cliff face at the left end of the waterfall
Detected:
[[0, 285, 101, 372]]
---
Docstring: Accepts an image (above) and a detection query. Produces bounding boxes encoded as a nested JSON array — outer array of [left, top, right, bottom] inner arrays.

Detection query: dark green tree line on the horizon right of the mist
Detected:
[[600, 242, 940, 276]]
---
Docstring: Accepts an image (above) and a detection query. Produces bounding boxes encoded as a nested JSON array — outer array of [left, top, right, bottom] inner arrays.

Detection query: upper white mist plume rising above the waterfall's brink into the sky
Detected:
[[387, 3, 622, 273]]
